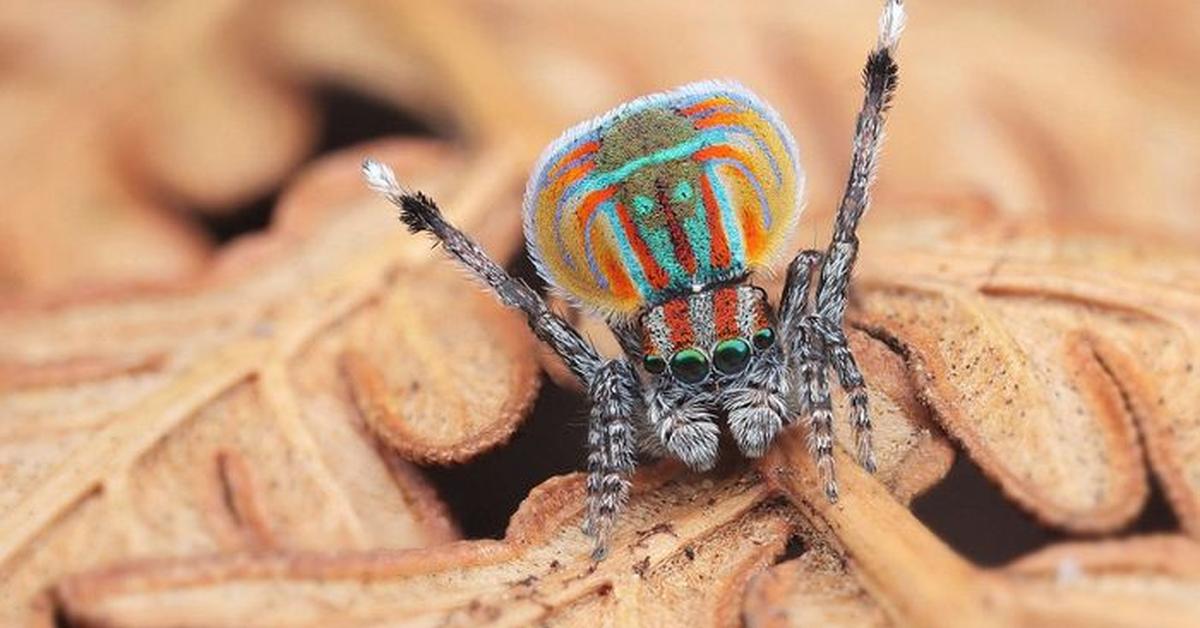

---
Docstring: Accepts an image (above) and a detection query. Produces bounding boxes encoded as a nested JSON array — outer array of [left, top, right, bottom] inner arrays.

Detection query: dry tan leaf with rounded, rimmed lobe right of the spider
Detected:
[[857, 201, 1200, 536]]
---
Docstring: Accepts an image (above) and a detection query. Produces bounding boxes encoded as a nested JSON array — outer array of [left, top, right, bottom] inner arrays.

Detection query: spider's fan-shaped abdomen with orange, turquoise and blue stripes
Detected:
[[524, 82, 804, 315]]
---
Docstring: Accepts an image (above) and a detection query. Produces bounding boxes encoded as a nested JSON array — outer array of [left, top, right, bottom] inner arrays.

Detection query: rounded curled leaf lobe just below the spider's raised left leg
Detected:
[[342, 267, 539, 462]]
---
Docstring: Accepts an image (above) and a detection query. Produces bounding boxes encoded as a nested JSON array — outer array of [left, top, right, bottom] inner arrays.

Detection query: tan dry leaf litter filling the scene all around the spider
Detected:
[[0, 0, 1200, 627]]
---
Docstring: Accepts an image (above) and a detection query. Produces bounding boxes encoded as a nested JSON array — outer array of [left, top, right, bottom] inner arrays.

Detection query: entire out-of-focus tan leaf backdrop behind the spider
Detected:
[[0, 0, 1200, 297]]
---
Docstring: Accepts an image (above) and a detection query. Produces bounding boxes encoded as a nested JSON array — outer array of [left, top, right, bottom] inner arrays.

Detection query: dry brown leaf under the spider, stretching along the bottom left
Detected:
[[49, 319, 950, 626]]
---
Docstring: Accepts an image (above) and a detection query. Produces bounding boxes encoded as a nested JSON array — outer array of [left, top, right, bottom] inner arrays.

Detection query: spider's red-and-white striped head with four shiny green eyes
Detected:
[[642, 285, 776, 387]]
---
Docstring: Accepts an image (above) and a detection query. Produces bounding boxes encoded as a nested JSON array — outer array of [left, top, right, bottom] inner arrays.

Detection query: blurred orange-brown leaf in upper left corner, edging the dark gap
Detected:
[[0, 2, 454, 293]]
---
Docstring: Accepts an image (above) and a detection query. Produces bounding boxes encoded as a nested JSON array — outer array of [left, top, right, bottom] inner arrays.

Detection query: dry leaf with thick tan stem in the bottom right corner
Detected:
[[744, 432, 1200, 627]]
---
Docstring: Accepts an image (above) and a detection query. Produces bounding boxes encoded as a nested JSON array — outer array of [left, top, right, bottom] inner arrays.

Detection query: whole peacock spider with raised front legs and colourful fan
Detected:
[[364, 0, 904, 557]]
